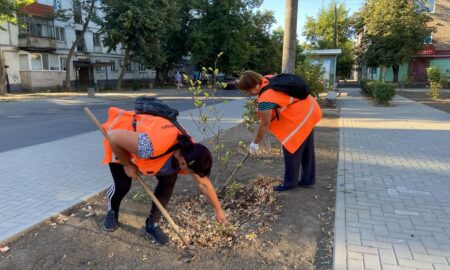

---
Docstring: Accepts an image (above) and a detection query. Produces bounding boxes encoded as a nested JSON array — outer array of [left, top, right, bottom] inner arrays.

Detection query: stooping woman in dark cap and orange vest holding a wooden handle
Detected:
[[102, 107, 226, 245]]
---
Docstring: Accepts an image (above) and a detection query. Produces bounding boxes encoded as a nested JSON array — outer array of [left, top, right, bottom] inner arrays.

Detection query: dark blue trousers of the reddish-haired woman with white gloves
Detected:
[[283, 130, 316, 187]]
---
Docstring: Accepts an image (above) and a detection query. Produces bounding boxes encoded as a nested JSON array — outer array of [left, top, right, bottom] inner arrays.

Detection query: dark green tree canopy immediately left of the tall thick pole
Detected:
[[189, 0, 273, 73]]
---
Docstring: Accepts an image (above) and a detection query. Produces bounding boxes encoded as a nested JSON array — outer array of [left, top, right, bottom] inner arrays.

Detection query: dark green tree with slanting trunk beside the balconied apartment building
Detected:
[[101, 0, 181, 88]]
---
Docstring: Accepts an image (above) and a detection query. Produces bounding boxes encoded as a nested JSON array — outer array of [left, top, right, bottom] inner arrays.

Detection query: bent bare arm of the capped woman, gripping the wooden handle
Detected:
[[108, 130, 139, 178]]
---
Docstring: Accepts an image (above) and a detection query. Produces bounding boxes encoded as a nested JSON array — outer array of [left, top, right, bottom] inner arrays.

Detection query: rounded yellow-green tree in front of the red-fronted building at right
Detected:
[[356, 0, 435, 82]]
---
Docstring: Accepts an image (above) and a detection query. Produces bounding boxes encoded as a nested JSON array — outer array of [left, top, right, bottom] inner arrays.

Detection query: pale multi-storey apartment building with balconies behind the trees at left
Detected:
[[0, 0, 155, 92]]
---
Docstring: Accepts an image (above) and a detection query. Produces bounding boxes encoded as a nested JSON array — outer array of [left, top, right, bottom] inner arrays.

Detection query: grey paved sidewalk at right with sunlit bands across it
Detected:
[[334, 89, 450, 270]]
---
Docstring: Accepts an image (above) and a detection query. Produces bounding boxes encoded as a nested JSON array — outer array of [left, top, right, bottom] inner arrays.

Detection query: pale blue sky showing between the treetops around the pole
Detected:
[[260, 0, 364, 42]]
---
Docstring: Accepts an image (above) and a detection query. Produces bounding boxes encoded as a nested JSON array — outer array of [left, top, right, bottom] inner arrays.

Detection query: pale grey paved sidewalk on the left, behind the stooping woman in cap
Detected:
[[0, 99, 245, 243]]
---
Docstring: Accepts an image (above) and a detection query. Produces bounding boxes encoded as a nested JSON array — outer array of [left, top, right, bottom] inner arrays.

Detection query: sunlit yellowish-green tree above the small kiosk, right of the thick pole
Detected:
[[304, 3, 354, 77]]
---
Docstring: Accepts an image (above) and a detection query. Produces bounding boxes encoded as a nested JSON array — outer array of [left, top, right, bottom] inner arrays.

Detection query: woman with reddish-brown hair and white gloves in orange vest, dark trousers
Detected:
[[239, 70, 322, 191]]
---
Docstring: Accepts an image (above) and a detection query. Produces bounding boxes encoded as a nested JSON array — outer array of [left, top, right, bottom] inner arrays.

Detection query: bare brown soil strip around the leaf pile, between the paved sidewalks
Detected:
[[0, 110, 339, 269]]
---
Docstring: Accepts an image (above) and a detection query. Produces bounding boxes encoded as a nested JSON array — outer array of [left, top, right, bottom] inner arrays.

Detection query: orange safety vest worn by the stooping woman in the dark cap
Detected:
[[102, 107, 182, 175]]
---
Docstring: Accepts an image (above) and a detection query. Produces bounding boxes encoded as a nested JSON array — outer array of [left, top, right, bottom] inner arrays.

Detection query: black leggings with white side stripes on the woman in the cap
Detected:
[[107, 163, 177, 222]]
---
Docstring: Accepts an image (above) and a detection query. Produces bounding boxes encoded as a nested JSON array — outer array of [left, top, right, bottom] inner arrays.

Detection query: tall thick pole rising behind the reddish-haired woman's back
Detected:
[[281, 0, 298, 73]]
